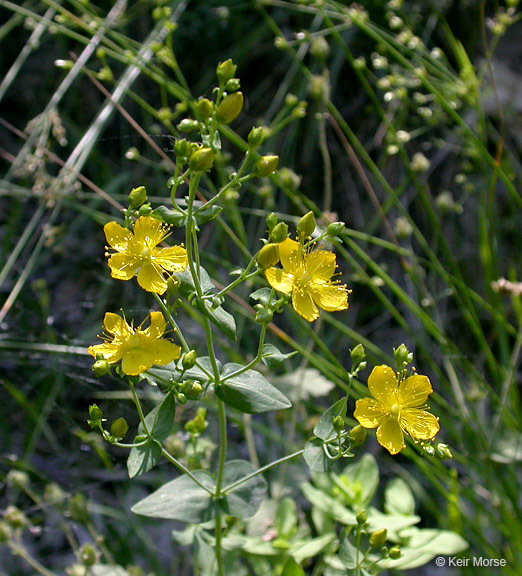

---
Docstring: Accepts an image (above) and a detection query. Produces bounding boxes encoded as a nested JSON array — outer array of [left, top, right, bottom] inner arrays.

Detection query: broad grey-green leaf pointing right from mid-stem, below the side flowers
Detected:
[[215, 363, 292, 414]]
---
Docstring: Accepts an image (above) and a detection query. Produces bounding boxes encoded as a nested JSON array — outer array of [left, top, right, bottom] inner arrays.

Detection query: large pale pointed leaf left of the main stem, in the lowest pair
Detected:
[[131, 470, 216, 524]]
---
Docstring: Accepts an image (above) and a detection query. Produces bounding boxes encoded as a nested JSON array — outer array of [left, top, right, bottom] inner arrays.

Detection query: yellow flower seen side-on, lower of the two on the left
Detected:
[[88, 312, 181, 376]]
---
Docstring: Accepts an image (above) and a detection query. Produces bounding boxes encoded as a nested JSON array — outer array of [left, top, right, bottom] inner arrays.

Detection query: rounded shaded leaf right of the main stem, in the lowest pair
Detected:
[[221, 460, 267, 518]]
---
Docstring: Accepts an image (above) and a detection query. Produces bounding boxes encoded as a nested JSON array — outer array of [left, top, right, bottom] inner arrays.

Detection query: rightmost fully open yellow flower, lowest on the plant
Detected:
[[353, 365, 440, 454]]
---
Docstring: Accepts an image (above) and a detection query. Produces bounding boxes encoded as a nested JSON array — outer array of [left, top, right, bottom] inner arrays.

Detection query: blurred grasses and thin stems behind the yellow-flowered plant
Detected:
[[0, 0, 522, 576]]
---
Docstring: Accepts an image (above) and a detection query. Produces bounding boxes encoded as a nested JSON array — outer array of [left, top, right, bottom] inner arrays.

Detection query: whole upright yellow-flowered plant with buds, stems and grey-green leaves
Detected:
[[89, 60, 447, 576]]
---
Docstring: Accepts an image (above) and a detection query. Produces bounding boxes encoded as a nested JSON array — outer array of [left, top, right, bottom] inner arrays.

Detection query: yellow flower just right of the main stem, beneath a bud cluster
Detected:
[[265, 238, 350, 322]]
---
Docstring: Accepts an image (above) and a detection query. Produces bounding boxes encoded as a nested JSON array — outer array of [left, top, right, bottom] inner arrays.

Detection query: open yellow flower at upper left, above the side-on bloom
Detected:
[[103, 216, 188, 294]]
